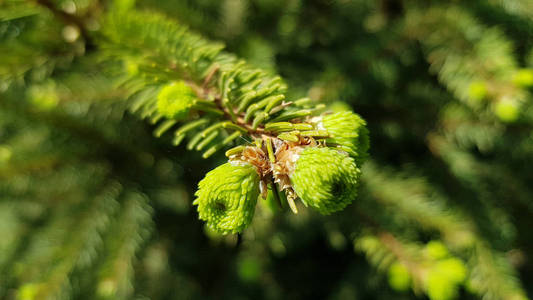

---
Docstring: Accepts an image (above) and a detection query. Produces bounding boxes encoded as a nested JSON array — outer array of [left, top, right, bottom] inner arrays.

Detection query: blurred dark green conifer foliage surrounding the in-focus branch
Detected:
[[0, 0, 533, 300]]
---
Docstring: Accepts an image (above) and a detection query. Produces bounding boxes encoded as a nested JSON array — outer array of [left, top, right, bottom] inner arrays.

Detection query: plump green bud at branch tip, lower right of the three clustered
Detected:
[[290, 147, 361, 215]]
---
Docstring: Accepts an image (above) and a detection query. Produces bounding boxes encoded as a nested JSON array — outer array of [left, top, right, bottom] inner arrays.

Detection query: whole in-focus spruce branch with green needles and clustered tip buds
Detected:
[[95, 7, 369, 233]]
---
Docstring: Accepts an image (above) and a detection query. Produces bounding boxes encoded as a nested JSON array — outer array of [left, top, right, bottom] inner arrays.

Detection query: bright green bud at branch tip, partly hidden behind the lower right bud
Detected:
[[319, 111, 370, 165]]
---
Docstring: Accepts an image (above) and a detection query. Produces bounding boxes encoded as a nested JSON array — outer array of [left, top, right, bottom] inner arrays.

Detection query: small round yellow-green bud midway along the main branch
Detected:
[[157, 81, 196, 120]]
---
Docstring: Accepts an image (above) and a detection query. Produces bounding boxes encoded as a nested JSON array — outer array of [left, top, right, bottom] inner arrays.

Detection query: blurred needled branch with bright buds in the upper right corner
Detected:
[[406, 5, 527, 122]]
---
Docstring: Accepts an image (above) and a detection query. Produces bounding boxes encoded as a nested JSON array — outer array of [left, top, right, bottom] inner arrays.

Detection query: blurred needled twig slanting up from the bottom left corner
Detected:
[[13, 184, 120, 299]]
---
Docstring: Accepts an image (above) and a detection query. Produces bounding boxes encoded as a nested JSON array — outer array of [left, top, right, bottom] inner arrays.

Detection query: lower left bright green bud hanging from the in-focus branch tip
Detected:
[[193, 162, 259, 234]]
